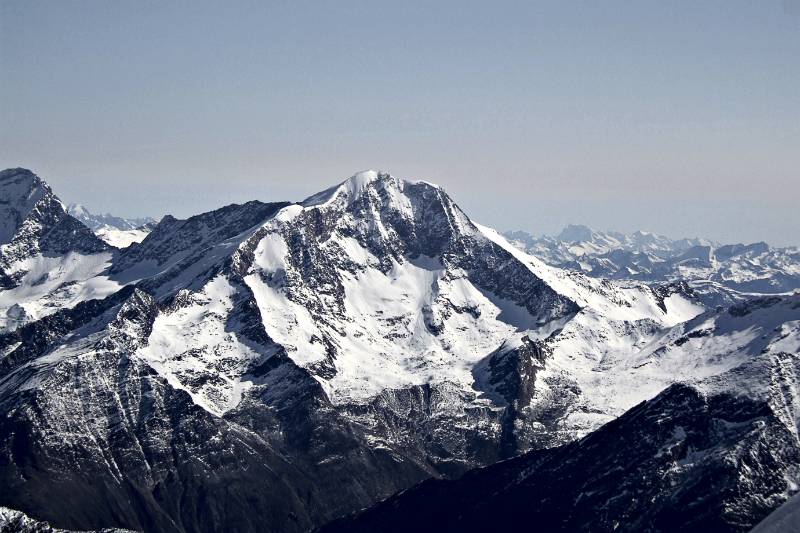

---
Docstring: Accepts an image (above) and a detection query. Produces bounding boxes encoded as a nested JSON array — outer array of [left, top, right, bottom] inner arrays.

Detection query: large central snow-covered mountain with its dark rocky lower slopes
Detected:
[[0, 171, 800, 531]]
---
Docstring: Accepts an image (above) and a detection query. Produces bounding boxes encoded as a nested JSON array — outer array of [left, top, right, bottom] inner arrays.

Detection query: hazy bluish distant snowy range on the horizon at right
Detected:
[[505, 225, 800, 294]]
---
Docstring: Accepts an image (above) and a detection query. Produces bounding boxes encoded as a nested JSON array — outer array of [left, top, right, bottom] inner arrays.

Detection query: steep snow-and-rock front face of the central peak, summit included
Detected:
[[228, 171, 578, 402]]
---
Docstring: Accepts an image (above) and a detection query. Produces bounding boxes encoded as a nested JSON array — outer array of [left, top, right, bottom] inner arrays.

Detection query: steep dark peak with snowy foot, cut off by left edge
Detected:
[[0, 169, 119, 331]]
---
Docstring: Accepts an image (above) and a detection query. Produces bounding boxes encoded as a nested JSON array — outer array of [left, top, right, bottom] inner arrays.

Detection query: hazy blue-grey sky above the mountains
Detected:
[[0, 0, 800, 245]]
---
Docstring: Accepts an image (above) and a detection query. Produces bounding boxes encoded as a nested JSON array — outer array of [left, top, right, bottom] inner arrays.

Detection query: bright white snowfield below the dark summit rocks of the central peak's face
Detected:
[[330, 254, 517, 400]]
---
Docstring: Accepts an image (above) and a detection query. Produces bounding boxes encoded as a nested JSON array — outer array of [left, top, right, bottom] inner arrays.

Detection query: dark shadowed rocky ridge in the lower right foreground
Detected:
[[322, 385, 800, 532]]
